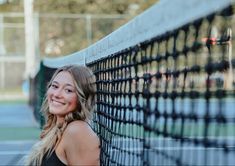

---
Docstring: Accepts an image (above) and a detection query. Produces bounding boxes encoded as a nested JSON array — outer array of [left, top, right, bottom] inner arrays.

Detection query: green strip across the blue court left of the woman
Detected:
[[0, 127, 41, 141]]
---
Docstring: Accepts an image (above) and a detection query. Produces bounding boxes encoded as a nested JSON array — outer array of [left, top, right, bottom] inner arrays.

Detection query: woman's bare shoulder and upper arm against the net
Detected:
[[64, 121, 100, 165]]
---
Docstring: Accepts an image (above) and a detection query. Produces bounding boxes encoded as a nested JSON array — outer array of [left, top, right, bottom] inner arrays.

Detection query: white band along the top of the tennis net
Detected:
[[42, 0, 231, 68]]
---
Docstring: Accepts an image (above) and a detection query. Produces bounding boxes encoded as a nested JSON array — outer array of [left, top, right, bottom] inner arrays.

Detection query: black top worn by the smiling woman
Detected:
[[41, 151, 66, 166]]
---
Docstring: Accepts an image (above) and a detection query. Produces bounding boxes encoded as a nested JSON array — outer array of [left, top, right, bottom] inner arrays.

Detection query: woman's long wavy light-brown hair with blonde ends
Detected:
[[26, 65, 96, 165]]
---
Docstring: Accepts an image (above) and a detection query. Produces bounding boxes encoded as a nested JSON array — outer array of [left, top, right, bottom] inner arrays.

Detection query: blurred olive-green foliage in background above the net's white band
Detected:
[[0, 0, 158, 57]]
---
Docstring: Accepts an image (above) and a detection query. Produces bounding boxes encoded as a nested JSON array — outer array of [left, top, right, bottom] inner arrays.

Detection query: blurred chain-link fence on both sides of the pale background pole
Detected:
[[0, 13, 130, 89]]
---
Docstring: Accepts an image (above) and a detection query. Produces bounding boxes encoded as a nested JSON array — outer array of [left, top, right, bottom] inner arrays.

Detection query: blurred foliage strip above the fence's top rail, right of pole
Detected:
[[34, 0, 158, 14]]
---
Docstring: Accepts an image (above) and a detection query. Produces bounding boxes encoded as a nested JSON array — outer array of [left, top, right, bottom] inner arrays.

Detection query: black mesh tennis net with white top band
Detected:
[[30, 0, 235, 166]]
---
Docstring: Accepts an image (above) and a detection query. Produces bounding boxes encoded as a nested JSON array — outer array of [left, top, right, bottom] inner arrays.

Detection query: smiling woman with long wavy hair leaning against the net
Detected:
[[26, 65, 100, 166]]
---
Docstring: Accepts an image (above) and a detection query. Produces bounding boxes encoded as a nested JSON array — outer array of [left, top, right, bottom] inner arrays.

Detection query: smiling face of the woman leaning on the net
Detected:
[[47, 71, 78, 118]]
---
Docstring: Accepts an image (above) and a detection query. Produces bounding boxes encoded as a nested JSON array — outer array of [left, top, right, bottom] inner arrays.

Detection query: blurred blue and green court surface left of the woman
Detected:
[[0, 102, 40, 165]]
